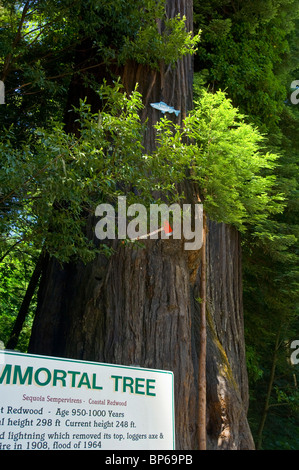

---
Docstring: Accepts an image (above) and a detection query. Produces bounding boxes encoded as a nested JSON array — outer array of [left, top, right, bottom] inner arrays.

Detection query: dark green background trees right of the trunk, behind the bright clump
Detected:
[[194, 0, 299, 449]]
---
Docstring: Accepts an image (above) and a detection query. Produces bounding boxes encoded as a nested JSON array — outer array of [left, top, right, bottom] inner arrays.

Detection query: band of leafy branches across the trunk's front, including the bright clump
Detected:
[[0, 82, 282, 262]]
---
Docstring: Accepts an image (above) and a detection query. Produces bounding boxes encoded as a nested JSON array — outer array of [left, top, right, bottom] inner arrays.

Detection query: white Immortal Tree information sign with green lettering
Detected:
[[0, 351, 175, 450]]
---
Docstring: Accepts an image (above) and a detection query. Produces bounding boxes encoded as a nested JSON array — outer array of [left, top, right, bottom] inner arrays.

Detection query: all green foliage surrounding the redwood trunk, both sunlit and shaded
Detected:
[[0, 0, 299, 449]]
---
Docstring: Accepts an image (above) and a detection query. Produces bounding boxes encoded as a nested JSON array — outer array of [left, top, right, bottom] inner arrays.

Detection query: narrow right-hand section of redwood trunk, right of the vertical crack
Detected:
[[206, 223, 254, 450]]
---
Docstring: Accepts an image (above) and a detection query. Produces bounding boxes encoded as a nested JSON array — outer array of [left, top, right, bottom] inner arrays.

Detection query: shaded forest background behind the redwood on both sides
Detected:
[[0, 0, 299, 450]]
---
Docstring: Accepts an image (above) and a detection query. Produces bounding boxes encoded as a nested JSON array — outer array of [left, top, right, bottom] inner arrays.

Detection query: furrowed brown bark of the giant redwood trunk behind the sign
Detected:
[[30, 0, 253, 449]]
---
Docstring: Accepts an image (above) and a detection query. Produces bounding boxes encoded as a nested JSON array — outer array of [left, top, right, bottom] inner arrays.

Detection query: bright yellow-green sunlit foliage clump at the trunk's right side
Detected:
[[156, 91, 284, 231]]
